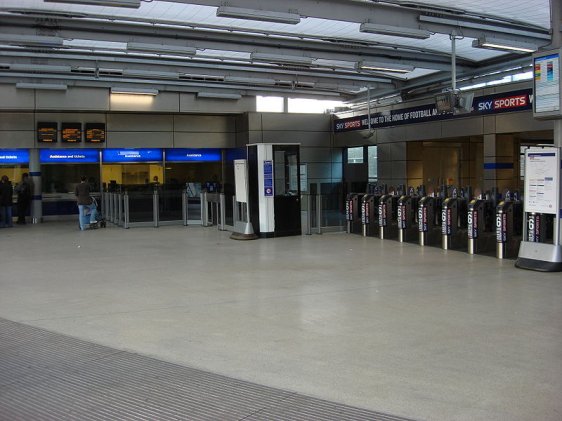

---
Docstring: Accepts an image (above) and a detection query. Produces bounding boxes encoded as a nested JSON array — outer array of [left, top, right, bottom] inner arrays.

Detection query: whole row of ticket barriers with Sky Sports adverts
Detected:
[[345, 185, 552, 259]]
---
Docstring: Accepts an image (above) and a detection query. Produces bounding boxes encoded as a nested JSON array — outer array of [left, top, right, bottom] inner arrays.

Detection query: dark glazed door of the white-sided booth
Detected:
[[273, 145, 301, 237]]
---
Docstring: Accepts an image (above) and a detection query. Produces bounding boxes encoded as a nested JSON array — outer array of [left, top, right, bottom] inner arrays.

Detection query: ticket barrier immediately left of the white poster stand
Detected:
[[496, 200, 520, 259]]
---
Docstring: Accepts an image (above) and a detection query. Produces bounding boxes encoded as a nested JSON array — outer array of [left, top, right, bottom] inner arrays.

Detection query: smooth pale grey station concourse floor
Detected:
[[0, 222, 562, 420]]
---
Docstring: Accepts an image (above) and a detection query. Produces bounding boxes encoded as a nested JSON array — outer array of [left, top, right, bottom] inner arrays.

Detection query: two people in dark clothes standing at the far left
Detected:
[[0, 173, 32, 228]]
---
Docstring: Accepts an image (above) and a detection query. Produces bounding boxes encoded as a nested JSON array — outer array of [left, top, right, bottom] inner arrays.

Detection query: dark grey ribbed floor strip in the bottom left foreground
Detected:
[[0, 319, 418, 421]]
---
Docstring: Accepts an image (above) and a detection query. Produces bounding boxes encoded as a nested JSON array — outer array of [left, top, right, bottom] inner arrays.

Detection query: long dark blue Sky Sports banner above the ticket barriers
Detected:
[[334, 89, 533, 133]]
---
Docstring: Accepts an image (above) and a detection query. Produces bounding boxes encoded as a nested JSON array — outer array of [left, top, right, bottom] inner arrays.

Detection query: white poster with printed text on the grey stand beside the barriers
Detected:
[[525, 147, 560, 215]]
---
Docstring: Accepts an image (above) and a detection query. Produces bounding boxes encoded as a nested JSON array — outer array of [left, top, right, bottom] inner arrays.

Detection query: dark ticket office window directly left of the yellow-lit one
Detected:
[[41, 163, 100, 194]]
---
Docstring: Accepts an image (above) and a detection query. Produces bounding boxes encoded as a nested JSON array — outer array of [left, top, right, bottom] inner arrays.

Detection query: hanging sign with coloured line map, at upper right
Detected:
[[533, 50, 562, 118]]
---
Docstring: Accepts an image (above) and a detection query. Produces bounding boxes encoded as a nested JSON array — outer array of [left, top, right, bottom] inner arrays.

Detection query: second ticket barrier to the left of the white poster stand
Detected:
[[467, 199, 496, 254]]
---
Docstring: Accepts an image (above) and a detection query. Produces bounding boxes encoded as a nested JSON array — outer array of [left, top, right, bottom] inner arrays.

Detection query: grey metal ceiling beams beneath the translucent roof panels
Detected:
[[0, 0, 551, 102]]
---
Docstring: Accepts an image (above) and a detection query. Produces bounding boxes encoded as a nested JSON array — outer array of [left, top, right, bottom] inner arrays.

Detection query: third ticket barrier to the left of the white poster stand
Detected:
[[441, 197, 468, 250]]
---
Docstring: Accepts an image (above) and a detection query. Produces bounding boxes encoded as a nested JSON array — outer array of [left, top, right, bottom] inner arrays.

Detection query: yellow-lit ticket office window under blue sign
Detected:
[[102, 163, 164, 186]]
